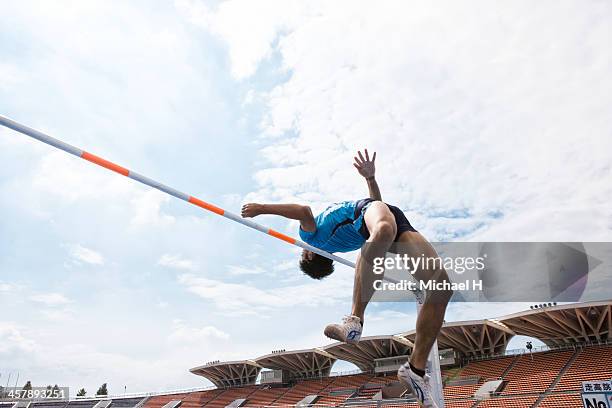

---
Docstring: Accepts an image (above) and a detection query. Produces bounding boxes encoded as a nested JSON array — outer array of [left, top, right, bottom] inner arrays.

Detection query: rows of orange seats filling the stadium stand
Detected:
[[26, 345, 612, 408]]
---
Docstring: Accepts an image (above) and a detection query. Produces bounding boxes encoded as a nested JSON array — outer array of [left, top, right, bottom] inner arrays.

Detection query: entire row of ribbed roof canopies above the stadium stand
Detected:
[[190, 300, 612, 387]]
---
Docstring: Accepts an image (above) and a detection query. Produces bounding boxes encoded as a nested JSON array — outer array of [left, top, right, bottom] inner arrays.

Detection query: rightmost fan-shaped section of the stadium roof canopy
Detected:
[[499, 301, 612, 346]]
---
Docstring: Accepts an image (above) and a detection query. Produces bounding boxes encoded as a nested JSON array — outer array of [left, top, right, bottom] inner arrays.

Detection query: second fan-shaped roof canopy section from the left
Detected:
[[255, 348, 336, 378]]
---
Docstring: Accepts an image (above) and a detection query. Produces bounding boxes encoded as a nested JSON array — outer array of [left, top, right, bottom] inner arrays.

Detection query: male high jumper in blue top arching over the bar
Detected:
[[242, 149, 452, 408]]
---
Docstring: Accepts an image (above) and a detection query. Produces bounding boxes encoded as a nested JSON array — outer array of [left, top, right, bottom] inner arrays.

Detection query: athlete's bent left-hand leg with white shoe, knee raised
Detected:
[[324, 201, 397, 343]]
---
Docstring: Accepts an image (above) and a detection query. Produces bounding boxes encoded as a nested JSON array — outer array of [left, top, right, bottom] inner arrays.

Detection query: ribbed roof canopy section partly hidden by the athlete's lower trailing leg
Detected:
[[402, 319, 514, 356]]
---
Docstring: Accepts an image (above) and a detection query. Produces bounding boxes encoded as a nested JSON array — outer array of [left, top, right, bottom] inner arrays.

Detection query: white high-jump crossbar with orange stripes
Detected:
[[0, 115, 355, 268]]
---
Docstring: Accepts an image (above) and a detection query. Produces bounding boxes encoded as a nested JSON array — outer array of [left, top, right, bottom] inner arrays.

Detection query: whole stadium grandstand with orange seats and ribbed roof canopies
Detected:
[[0, 301, 612, 408]]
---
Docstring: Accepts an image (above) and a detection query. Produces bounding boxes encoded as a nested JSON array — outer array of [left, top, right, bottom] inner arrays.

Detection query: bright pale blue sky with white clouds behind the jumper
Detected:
[[0, 0, 612, 393]]
